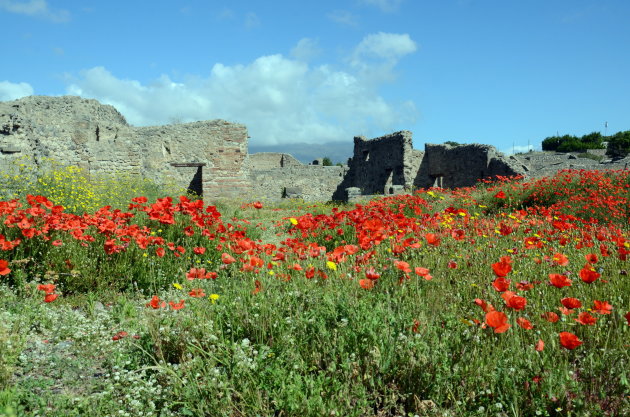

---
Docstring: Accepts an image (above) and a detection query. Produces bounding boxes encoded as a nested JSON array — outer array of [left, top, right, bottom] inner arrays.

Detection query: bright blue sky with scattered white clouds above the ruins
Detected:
[[0, 0, 630, 159]]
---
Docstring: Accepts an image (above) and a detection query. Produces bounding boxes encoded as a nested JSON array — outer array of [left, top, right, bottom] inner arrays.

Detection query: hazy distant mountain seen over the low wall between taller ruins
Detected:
[[249, 140, 354, 164]]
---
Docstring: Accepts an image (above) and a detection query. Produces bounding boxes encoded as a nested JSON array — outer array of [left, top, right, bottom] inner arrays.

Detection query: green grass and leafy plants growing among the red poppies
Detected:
[[0, 164, 630, 417]]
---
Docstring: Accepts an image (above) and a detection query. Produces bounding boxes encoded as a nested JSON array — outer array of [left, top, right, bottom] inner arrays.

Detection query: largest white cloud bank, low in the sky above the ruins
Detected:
[[67, 35, 416, 145]]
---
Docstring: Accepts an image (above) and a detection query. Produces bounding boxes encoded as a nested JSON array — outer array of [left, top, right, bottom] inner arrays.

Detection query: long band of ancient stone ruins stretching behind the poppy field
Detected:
[[0, 96, 628, 201]]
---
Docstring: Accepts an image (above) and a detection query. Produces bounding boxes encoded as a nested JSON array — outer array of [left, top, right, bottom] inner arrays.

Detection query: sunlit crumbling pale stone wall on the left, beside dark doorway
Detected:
[[0, 96, 250, 198]]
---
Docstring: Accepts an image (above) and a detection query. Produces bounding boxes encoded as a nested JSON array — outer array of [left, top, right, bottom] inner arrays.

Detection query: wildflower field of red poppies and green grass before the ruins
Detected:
[[0, 170, 630, 417]]
